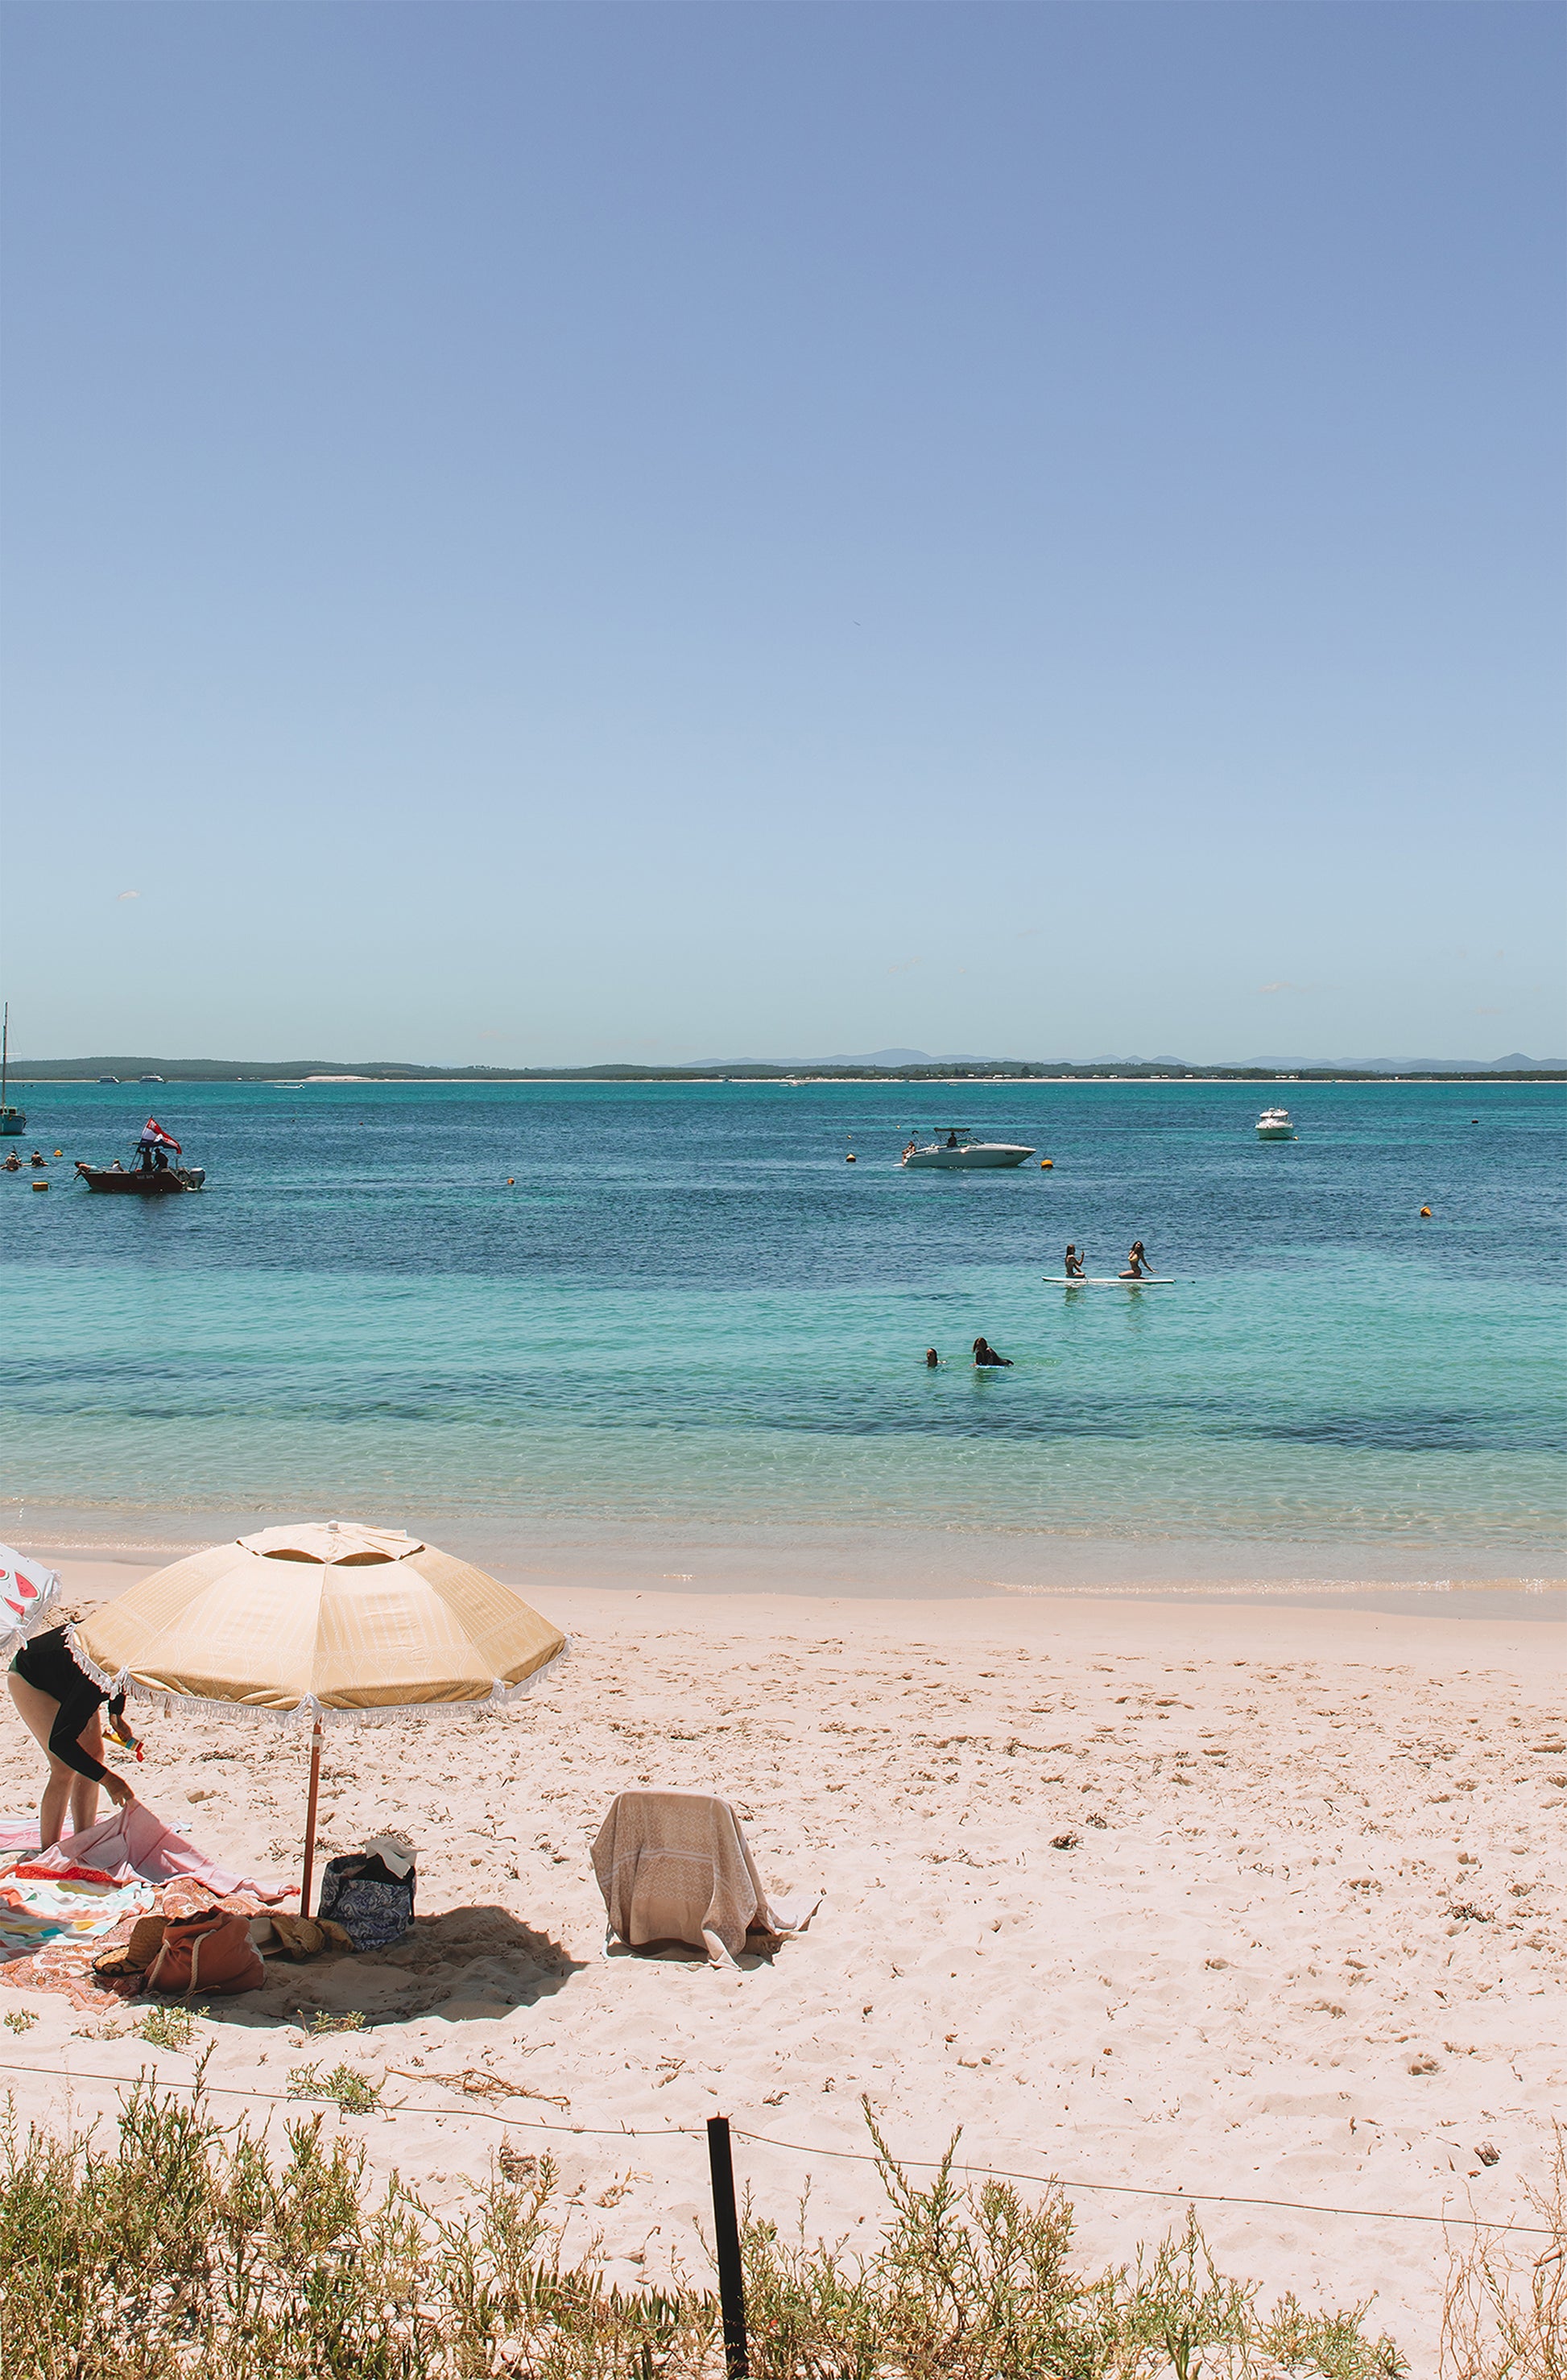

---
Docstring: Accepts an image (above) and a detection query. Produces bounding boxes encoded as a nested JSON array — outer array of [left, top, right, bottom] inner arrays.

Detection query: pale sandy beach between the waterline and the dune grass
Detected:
[[0, 1561, 1567, 2368]]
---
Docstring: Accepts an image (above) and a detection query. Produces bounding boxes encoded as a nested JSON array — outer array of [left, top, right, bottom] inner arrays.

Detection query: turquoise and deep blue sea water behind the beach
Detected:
[[0, 1083, 1567, 1593]]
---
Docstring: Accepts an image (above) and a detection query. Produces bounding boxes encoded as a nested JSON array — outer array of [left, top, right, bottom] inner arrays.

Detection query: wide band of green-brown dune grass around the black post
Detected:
[[0, 2078, 1405, 2380]]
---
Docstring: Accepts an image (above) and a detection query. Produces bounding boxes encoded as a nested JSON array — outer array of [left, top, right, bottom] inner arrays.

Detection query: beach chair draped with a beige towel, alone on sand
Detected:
[[593, 1785, 821, 1966]]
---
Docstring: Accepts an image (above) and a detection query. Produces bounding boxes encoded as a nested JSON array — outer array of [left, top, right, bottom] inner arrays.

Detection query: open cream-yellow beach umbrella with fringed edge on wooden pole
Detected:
[[72, 1521, 569, 1916]]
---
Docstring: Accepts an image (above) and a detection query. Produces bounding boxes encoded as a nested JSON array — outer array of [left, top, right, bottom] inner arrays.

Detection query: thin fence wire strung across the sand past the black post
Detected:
[[0, 2059, 1560, 2240]]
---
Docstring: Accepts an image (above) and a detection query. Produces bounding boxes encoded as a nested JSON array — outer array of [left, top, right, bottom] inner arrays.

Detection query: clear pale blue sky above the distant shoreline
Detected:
[[5, 0, 1567, 1064]]
